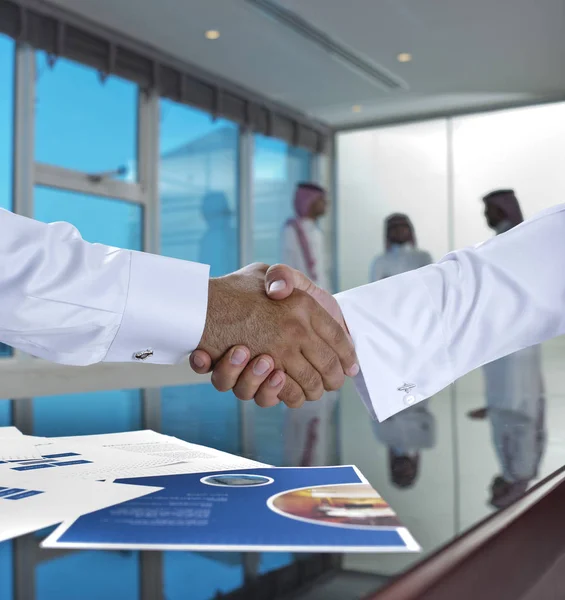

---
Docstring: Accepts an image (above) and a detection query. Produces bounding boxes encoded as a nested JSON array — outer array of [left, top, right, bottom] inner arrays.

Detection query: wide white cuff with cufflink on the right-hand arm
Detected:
[[336, 267, 453, 421]]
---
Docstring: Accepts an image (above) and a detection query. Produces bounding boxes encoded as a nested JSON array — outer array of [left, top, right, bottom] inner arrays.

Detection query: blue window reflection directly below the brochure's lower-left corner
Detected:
[[35, 552, 140, 600]]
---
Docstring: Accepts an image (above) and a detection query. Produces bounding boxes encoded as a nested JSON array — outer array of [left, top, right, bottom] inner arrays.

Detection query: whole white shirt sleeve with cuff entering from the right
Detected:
[[336, 205, 565, 421]]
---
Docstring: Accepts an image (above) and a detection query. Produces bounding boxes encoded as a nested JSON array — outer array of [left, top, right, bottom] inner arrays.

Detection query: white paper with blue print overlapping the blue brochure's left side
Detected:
[[0, 471, 160, 542]]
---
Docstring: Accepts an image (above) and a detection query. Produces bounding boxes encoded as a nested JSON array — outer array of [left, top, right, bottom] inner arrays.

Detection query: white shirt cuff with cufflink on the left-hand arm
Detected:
[[104, 252, 210, 364]]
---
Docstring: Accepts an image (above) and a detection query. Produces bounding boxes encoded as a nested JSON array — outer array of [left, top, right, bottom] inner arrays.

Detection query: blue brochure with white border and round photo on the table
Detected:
[[42, 466, 420, 552]]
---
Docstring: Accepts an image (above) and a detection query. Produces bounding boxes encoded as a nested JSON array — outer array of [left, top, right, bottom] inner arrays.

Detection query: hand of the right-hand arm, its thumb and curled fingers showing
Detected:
[[190, 265, 359, 407]]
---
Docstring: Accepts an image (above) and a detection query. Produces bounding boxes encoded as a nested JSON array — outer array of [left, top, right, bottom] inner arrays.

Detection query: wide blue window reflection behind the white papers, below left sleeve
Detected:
[[33, 390, 141, 437]]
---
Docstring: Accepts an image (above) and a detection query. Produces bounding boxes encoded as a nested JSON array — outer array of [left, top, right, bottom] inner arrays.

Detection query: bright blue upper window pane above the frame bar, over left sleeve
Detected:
[[35, 52, 137, 179]]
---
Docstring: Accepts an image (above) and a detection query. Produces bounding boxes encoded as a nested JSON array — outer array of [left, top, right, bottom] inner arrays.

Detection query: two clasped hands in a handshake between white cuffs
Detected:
[[190, 264, 359, 408]]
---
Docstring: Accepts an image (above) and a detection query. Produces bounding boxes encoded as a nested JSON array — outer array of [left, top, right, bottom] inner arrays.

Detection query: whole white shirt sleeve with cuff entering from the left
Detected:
[[0, 210, 209, 365]]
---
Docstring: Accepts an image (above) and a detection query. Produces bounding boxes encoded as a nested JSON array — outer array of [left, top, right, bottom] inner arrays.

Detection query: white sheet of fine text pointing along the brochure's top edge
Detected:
[[54, 430, 268, 477]]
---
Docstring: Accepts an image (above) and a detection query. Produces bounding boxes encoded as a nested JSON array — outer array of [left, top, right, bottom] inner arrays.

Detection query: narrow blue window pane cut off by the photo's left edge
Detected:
[[0, 35, 15, 357]]
